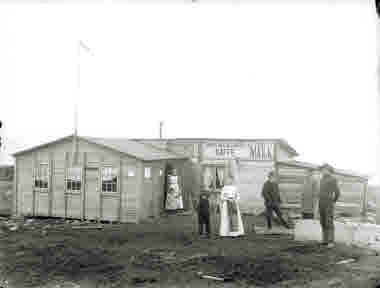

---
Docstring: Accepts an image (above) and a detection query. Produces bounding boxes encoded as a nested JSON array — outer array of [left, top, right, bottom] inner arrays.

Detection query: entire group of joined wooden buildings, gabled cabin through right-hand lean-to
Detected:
[[13, 135, 368, 223]]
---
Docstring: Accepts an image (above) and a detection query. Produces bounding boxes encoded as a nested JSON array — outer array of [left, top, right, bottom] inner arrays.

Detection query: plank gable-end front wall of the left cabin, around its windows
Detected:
[[15, 143, 142, 222]]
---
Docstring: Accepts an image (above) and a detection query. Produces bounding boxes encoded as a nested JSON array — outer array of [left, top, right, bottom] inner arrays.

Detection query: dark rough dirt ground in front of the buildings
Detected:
[[0, 216, 380, 288]]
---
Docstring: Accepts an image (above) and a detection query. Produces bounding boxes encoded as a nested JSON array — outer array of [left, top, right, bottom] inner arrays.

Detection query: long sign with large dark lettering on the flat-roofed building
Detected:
[[203, 142, 274, 161]]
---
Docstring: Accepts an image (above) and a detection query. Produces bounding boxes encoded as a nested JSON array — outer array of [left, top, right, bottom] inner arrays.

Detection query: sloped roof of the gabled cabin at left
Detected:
[[13, 135, 188, 161]]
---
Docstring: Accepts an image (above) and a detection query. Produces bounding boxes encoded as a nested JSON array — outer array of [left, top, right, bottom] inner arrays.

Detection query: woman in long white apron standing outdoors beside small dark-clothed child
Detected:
[[219, 175, 244, 237]]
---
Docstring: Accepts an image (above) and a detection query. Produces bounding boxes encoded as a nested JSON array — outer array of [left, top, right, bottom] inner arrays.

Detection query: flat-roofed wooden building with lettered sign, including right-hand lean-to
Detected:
[[135, 138, 368, 215]]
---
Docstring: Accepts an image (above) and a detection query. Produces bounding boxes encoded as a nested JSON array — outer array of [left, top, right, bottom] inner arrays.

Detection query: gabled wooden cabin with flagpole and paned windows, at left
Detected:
[[13, 135, 187, 223]]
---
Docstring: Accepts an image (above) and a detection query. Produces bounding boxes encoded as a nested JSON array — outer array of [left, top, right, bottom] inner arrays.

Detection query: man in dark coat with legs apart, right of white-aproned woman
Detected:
[[261, 172, 290, 230]]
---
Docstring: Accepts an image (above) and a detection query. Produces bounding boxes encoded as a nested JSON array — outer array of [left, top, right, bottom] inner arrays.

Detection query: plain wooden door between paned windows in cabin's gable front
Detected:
[[84, 168, 100, 220]]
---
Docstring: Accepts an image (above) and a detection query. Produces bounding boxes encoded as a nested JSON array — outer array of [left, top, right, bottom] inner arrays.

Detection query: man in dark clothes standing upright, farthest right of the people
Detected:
[[319, 164, 340, 248]]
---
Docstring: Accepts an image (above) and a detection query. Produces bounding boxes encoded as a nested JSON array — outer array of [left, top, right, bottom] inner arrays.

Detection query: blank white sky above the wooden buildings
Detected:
[[0, 0, 380, 183]]
